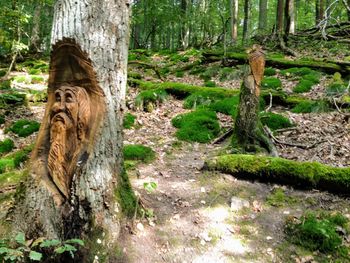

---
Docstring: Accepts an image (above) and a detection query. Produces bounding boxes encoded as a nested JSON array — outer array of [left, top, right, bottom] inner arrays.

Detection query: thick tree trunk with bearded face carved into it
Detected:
[[9, 0, 134, 262]]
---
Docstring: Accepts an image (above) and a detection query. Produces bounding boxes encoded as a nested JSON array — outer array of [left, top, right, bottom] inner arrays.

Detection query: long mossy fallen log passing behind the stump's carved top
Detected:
[[202, 51, 350, 75]]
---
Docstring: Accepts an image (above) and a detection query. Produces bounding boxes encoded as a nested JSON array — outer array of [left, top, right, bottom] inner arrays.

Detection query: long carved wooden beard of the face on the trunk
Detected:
[[48, 112, 77, 198]]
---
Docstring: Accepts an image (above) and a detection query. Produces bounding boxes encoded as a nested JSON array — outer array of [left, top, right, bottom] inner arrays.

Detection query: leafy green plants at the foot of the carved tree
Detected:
[[0, 232, 84, 262]]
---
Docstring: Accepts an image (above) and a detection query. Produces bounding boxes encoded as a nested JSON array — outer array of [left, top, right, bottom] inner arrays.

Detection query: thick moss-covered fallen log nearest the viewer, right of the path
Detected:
[[207, 154, 350, 194]]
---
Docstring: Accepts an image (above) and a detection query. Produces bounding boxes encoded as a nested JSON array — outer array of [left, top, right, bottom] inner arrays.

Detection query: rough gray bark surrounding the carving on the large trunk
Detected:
[[14, 0, 129, 262]]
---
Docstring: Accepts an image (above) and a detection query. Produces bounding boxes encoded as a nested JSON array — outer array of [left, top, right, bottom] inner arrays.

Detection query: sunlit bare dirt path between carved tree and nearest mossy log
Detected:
[[123, 101, 350, 263]]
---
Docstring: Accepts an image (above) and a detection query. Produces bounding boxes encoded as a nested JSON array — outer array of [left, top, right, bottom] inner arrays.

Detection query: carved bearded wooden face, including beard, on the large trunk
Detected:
[[48, 86, 91, 197]]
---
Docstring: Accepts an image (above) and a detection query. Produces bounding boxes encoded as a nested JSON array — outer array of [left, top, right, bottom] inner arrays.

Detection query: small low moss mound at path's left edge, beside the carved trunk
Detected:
[[123, 144, 155, 163]]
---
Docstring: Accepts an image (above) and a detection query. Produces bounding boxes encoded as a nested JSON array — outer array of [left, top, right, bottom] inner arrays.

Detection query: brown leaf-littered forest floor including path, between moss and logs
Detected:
[[0, 48, 350, 263]]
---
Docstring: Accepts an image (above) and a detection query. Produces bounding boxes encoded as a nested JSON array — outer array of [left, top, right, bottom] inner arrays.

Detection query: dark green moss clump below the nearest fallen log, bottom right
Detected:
[[285, 213, 348, 255]]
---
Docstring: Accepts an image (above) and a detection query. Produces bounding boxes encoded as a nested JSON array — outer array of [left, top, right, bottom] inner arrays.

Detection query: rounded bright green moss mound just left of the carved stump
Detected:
[[171, 110, 220, 143]]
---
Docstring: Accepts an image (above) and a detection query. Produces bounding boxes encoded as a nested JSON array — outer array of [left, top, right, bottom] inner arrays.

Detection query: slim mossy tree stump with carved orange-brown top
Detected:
[[233, 45, 277, 156]]
